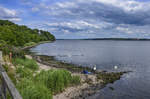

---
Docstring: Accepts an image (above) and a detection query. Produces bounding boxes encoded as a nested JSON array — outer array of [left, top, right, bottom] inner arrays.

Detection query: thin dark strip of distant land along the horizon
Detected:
[[56, 38, 150, 41]]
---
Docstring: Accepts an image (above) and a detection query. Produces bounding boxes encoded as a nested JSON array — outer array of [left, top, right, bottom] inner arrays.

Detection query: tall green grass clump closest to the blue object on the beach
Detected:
[[35, 70, 80, 94]]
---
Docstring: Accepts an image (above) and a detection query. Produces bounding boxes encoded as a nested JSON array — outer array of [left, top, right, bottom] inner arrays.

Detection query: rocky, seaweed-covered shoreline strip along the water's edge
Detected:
[[29, 53, 128, 99]]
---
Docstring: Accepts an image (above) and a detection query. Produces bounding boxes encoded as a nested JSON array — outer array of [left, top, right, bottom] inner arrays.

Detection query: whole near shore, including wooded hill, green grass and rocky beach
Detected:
[[0, 20, 127, 99]]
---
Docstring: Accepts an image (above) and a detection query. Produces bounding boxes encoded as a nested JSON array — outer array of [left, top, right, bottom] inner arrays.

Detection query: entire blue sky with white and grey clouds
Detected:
[[0, 0, 150, 39]]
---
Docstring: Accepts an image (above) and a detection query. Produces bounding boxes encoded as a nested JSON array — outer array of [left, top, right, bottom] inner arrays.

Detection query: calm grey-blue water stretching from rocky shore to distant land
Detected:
[[31, 40, 150, 99]]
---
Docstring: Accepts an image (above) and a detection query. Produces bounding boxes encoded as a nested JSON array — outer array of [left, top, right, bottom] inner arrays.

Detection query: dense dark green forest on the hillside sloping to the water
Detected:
[[0, 20, 55, 46]]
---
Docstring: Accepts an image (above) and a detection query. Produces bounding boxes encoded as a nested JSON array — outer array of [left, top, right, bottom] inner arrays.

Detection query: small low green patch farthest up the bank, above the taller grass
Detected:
[[13, 58, 39, 70]]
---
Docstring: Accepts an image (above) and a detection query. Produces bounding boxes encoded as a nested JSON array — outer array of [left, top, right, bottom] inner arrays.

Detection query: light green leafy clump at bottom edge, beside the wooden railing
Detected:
[[17, 78, 52, 99]]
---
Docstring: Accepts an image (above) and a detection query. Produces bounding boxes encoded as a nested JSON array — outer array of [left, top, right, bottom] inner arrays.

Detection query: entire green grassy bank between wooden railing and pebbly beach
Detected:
[[4, 57, 80, 99]]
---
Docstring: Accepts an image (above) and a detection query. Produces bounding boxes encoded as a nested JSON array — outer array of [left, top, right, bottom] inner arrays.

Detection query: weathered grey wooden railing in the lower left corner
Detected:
[[0, 52, 22, 99]]
